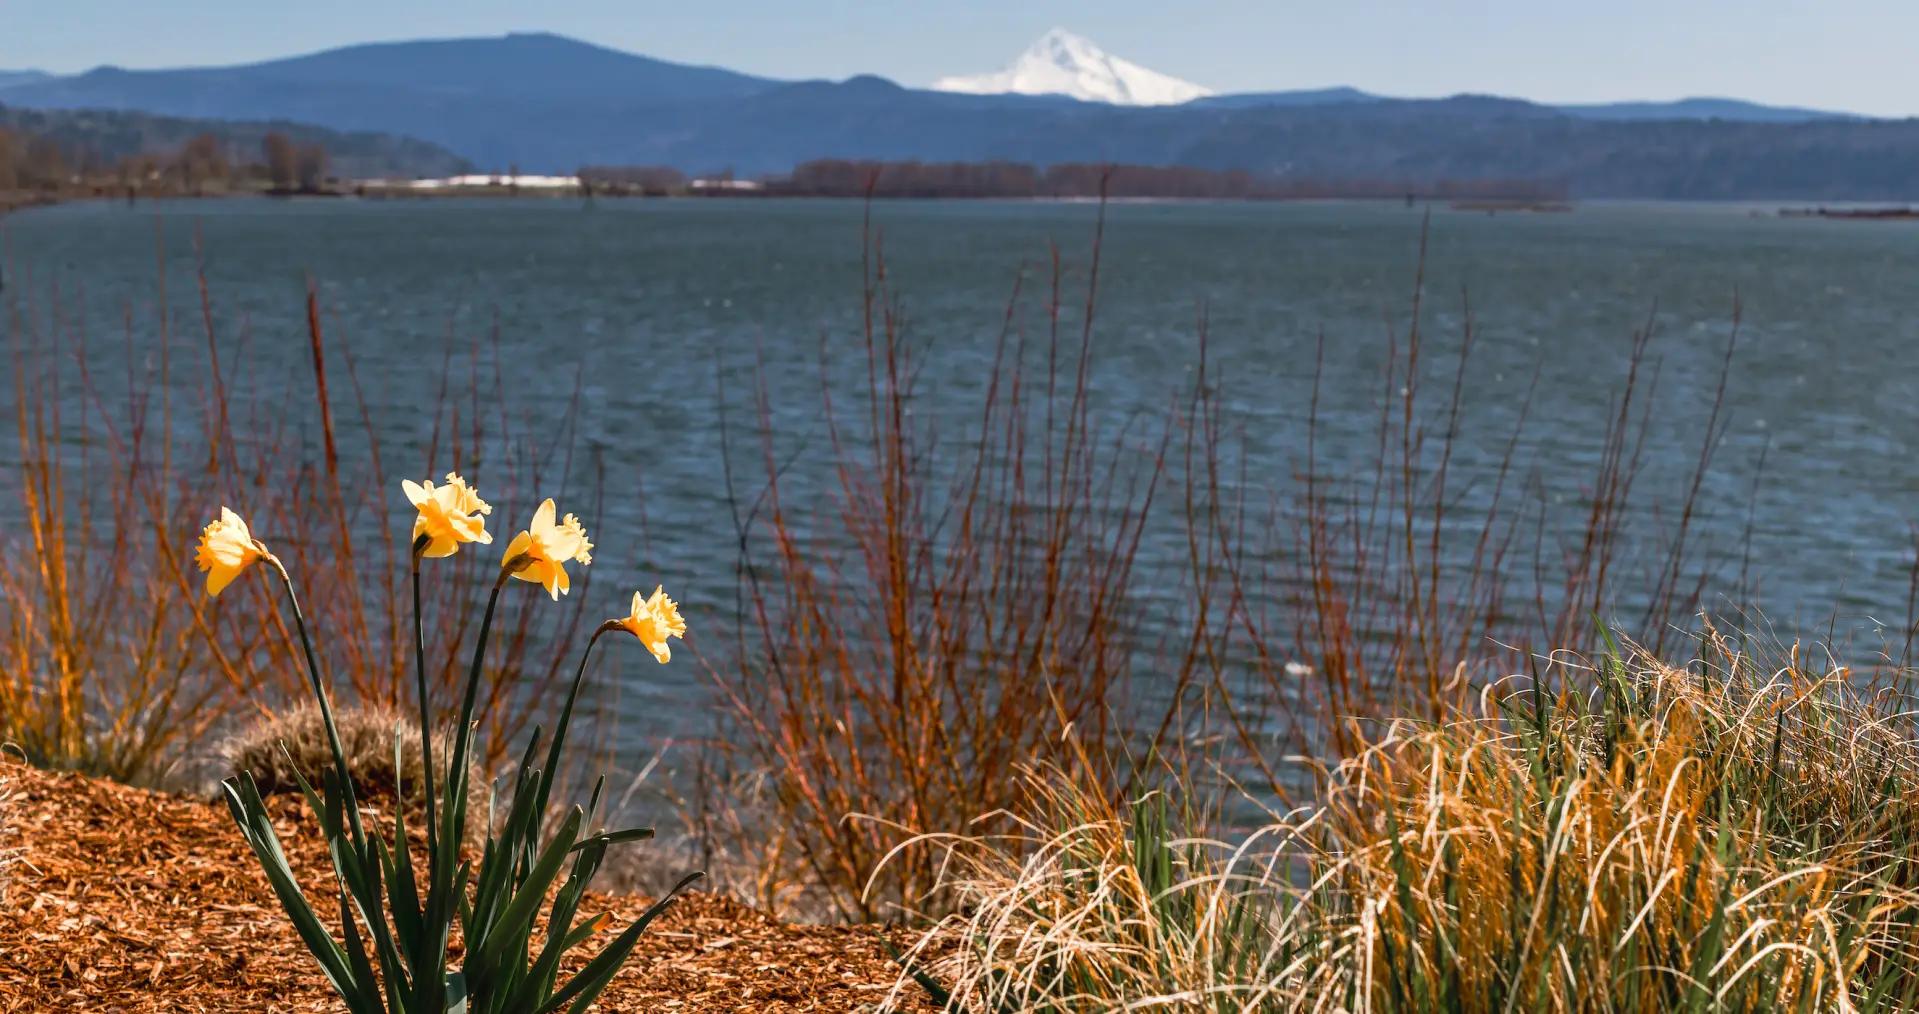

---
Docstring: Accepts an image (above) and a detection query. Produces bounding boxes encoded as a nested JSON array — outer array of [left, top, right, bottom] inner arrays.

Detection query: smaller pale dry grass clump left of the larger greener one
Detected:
[[888, 764, 1293, 1010]]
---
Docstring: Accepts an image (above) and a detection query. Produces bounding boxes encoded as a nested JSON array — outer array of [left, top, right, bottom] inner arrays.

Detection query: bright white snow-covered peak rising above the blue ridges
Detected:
[[933, 29, 1213, 106]]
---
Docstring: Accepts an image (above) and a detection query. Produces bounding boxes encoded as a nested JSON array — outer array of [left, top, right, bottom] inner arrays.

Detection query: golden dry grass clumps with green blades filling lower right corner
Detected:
[[898, 636, 1919, 1010]]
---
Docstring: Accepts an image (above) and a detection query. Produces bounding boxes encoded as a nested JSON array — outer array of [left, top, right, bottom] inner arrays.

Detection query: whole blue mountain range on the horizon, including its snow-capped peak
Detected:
[[0, 31, 1919, 200]]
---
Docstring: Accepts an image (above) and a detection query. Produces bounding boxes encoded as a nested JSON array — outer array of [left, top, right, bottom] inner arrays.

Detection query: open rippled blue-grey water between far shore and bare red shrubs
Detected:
[[0, 200, 1919, 741]]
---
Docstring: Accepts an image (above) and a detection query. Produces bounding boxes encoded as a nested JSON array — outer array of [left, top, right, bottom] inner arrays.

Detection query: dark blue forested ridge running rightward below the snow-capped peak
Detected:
[[571, 79, 1919, 200]]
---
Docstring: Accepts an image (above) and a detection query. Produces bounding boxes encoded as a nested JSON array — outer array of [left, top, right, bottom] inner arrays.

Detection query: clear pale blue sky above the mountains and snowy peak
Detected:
[[0, 0, 1919, 115]]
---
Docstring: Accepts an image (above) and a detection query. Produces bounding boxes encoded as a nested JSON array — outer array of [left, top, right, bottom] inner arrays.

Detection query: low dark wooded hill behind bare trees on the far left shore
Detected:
[[0, 106, 470, 177]]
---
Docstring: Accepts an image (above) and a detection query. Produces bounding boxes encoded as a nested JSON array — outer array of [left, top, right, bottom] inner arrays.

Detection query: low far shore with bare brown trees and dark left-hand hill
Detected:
[[0, 97, 1919, 221]]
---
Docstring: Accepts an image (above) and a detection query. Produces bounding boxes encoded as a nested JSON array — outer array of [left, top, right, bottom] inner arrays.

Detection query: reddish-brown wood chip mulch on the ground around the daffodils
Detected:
[[0, 761, 923, 1014]]
